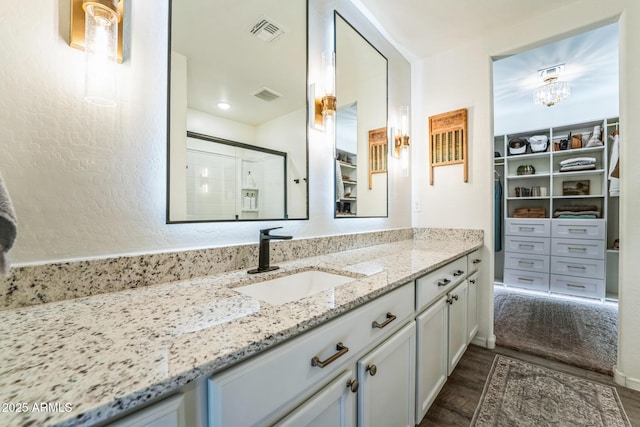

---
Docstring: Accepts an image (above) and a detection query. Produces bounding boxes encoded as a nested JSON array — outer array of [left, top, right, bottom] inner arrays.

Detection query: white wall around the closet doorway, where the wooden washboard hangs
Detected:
[[412, 0, 640, 389]]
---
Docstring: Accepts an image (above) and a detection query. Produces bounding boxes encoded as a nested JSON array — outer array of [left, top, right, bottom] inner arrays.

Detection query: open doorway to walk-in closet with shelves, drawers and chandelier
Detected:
[[493, 23, 623, 368]]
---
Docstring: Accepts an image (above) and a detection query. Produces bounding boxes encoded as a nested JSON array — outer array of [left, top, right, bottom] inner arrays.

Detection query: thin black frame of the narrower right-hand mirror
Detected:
[[333, 10, 390, 219]]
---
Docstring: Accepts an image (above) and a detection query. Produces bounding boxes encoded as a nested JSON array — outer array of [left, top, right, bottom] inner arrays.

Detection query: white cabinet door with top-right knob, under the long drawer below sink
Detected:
[[276, 370, 358, 427]]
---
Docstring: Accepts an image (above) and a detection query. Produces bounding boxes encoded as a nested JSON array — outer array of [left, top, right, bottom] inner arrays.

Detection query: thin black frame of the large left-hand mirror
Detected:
[[165, 0, 310, 224]]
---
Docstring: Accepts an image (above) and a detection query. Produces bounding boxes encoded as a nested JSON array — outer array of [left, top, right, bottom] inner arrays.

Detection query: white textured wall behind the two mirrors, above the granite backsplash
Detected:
[[0, 0, 411, 265]]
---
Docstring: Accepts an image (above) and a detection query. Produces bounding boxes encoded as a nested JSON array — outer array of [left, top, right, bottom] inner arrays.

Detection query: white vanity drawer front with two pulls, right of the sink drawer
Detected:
[[416, 257, 467, 311]]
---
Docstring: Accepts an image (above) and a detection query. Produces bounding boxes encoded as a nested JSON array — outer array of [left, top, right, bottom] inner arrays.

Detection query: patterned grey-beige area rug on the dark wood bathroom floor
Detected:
[[471, 355, 631, 427]]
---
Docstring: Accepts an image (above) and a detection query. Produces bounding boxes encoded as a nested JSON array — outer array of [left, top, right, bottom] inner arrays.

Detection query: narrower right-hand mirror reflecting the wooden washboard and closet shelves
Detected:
[[334, 11, 388, 218]]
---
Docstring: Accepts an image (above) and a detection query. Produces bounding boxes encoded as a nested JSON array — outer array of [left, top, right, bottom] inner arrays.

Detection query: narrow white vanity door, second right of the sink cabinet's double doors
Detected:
[[447, 280, 468, 375]]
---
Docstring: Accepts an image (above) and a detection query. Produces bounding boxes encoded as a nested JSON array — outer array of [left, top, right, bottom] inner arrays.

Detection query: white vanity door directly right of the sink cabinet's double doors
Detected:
[[416, 296, 449, 423]]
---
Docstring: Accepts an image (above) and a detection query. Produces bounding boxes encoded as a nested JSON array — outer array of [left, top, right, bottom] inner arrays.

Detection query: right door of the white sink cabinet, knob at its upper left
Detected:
[[356, 322, 416, 427]]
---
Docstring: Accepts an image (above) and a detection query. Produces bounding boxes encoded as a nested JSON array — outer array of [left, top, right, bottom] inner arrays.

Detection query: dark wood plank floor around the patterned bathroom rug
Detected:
[[419, 345, 640, 427]]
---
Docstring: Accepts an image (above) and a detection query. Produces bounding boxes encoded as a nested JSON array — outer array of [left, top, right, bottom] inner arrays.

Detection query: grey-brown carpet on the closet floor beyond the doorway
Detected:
[[494, 287, 618, 375]]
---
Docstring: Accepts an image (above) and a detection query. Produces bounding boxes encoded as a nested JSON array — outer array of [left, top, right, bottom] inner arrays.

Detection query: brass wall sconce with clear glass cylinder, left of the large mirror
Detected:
[[69, 0, 124, 106]]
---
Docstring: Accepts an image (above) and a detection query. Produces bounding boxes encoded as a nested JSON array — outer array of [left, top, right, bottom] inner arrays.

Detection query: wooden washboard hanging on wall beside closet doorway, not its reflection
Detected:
[[429, 108, 469, 185]]
